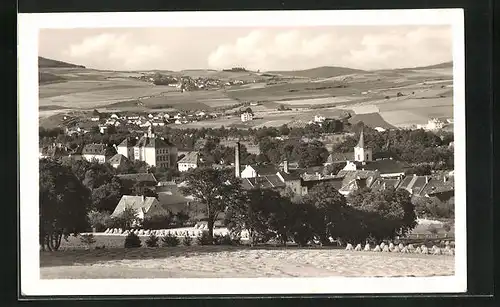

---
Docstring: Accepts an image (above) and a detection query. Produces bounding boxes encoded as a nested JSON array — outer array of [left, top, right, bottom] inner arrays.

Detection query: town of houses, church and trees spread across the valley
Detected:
[[39, 109, 454, 249]]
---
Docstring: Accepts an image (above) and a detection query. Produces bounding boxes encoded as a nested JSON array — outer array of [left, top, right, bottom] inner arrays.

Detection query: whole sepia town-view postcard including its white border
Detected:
[[19, 9, 467, 295]]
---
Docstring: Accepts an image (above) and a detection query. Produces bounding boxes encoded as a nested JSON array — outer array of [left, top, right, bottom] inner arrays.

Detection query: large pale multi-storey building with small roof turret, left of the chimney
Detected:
[[118, 127, 177, 168]]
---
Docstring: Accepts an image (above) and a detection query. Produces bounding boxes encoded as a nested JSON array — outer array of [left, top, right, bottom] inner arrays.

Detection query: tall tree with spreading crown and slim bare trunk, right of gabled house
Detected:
[[181, 168, 241, 239]]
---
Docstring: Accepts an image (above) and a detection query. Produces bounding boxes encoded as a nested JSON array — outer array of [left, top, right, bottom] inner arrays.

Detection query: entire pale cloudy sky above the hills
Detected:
[[39, 25, 452, 71]]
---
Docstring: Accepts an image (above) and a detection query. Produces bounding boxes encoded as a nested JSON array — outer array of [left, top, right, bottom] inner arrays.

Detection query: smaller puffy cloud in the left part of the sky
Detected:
[[63, 33, 167, 70]]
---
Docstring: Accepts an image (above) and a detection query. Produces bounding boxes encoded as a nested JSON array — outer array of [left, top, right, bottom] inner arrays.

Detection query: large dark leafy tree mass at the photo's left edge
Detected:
[[39, 159, 90, 251]]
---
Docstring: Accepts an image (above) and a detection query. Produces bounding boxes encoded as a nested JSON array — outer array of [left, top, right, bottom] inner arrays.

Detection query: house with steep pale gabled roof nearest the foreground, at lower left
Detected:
[[111, 195, 168, 220]]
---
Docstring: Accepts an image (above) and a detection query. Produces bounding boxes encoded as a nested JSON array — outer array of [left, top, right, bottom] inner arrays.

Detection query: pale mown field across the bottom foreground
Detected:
[[40, 246, 454, 279]]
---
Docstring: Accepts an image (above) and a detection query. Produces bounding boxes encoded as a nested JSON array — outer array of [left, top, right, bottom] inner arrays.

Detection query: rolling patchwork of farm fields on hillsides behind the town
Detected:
[[39, 59, 453, 128]]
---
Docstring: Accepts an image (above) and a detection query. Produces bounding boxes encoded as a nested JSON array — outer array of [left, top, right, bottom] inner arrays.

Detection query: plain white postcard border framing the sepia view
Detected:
[[18, 9, 467, 296]]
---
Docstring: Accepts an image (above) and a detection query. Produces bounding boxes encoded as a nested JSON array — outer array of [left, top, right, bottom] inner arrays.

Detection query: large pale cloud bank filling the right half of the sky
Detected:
[[207, 26, 452, 70]]
